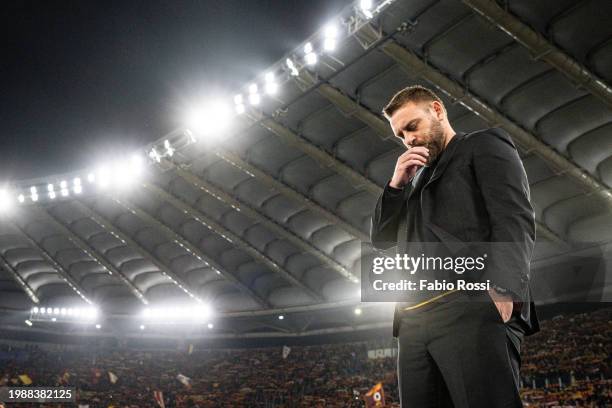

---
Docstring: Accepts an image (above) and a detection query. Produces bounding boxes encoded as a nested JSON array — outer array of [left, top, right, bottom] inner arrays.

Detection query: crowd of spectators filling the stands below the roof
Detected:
[[0, 309, 612, 408]]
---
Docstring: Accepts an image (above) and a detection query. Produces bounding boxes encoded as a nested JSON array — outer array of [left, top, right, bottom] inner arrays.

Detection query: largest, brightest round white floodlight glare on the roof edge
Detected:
[[187, 100, 232, 138]]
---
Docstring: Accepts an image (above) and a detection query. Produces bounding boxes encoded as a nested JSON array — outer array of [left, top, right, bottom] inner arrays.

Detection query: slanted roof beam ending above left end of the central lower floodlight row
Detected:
[[31, 206, 149, 305]]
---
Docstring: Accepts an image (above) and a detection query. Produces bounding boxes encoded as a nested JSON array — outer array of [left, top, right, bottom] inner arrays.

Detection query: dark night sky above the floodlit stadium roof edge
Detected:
[[0, 0, 350, 182]]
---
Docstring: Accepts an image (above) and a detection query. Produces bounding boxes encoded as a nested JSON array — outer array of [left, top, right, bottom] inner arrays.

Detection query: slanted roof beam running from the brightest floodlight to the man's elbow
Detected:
[[215, 147, 370, 241]]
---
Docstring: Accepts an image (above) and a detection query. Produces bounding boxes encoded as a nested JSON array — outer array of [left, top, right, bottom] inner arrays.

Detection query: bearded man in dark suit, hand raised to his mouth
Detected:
[[371, 86, 539, 408]]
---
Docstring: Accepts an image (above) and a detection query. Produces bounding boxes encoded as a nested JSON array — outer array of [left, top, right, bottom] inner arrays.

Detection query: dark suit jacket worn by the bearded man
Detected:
[[371, 128, 539, 337]]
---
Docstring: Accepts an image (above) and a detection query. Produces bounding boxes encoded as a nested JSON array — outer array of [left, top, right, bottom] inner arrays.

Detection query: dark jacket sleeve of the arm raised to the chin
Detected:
[[370, 183, 412, 249]]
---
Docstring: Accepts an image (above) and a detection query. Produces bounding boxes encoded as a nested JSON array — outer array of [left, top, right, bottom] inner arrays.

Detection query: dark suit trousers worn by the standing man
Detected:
[[398, 292, 523, 408]]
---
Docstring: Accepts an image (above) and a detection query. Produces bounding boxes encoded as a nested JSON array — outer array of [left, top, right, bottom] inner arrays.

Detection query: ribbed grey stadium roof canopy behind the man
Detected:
[[0, 0, 612, 344]]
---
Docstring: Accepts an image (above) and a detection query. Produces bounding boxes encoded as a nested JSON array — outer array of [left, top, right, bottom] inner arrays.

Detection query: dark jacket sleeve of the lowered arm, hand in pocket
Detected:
[[472, 129, 535, 301]]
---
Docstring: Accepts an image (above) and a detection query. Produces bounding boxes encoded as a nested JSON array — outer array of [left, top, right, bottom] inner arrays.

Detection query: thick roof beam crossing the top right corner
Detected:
[[463, 0, 612, 108]]
